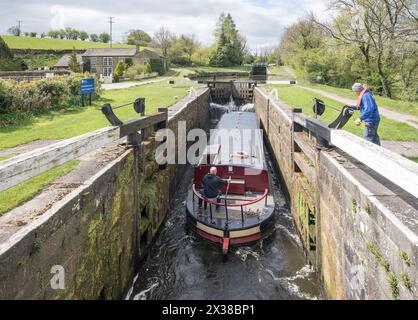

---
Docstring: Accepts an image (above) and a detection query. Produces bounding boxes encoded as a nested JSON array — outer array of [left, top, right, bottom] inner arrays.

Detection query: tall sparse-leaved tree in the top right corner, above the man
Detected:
[[317, 0, 418, 97]]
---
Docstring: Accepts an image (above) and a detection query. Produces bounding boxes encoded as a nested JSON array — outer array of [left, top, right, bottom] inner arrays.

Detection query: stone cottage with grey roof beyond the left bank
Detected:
[[81, 48, 167, 78]]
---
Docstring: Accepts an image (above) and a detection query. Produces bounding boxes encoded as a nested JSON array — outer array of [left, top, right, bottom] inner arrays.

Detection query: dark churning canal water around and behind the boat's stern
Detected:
[[127, 150, 321, 300]]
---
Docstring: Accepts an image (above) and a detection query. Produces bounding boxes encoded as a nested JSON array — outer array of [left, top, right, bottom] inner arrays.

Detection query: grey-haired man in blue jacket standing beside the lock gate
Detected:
[[352, 83, 380, 146]]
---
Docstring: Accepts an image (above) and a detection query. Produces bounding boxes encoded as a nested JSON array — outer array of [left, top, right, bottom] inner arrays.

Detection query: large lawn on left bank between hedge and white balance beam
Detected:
[[0, 77, 198, 150]]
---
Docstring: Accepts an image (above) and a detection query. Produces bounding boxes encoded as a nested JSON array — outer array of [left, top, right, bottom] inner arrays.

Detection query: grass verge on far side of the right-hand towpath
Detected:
[[309, 85, 418, 116]]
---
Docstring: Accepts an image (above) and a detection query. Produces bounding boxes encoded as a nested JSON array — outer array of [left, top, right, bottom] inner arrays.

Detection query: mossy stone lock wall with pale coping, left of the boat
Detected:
[[0, 90, 209, 299]]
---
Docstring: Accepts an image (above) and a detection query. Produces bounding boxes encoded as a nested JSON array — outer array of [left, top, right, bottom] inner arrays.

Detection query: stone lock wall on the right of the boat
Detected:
[[255, 88, 418, 299]]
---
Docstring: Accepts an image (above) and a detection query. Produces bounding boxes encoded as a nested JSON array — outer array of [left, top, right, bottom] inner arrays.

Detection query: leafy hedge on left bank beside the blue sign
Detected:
[[0, 74, 100, 127]]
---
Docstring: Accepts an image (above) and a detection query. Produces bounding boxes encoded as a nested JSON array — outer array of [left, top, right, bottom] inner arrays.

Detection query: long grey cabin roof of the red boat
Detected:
[[204, 112, 266, 170]]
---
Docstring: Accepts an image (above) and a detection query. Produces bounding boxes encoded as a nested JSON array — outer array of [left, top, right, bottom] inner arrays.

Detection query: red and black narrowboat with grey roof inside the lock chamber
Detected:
[[186, 112, 275, 254]]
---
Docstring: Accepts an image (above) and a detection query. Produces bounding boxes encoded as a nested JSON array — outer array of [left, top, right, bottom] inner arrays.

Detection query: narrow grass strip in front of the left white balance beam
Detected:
[[0, 160, 79, 216]]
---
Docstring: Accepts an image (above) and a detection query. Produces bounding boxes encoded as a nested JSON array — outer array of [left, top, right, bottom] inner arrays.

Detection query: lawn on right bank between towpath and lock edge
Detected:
[[266, 85, 418, 141]]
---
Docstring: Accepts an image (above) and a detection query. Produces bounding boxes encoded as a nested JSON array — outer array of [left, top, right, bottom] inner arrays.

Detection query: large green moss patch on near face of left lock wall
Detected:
[[61, 153, 135, 299]]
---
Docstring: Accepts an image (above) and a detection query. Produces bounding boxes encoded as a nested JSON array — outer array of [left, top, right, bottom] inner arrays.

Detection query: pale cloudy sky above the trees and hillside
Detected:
[[0, 0, 330, 49]]
